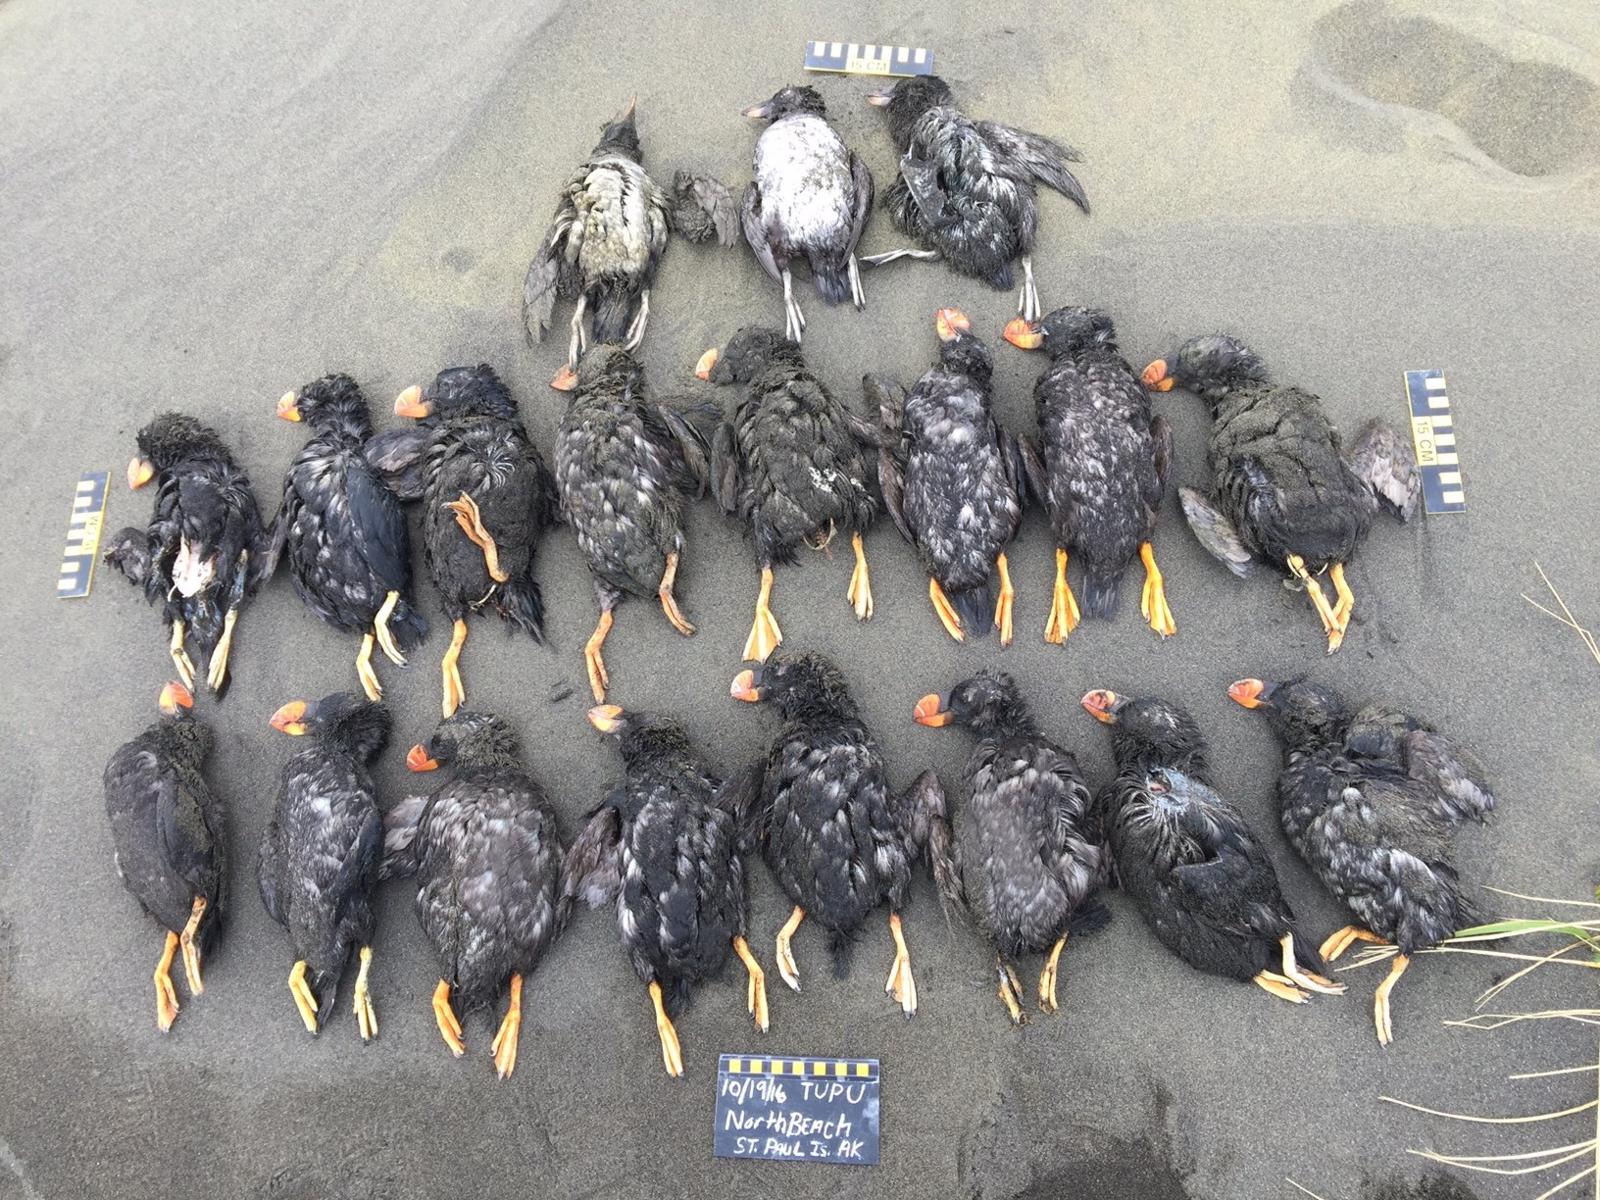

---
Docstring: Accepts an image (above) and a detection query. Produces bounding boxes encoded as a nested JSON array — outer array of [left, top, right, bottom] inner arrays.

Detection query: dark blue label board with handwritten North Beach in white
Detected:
[[714, 1054, 878, 1166]]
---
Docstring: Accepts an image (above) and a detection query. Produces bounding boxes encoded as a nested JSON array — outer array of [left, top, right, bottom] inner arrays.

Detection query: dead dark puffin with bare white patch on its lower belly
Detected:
[[106, 413, 269, 693]]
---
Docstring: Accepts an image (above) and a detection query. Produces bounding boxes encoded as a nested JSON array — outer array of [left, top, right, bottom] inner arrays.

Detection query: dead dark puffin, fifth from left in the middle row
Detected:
[[694, 325, 880, 661]]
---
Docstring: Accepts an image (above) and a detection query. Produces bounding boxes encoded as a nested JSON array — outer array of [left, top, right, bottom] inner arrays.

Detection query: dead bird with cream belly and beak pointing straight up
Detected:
[[522, 98, 739, 368]]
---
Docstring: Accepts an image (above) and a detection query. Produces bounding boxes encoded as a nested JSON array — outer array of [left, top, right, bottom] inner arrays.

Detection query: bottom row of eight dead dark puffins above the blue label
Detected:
[[106, 654, 1494, 1078]]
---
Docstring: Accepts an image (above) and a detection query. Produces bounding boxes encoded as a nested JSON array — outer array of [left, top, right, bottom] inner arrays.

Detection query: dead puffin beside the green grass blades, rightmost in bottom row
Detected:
[[1227, 678, 1494, 1045]]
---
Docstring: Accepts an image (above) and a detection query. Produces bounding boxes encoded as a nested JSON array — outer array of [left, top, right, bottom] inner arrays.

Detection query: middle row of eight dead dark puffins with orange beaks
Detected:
[[107, 307, 1418, 729]]
